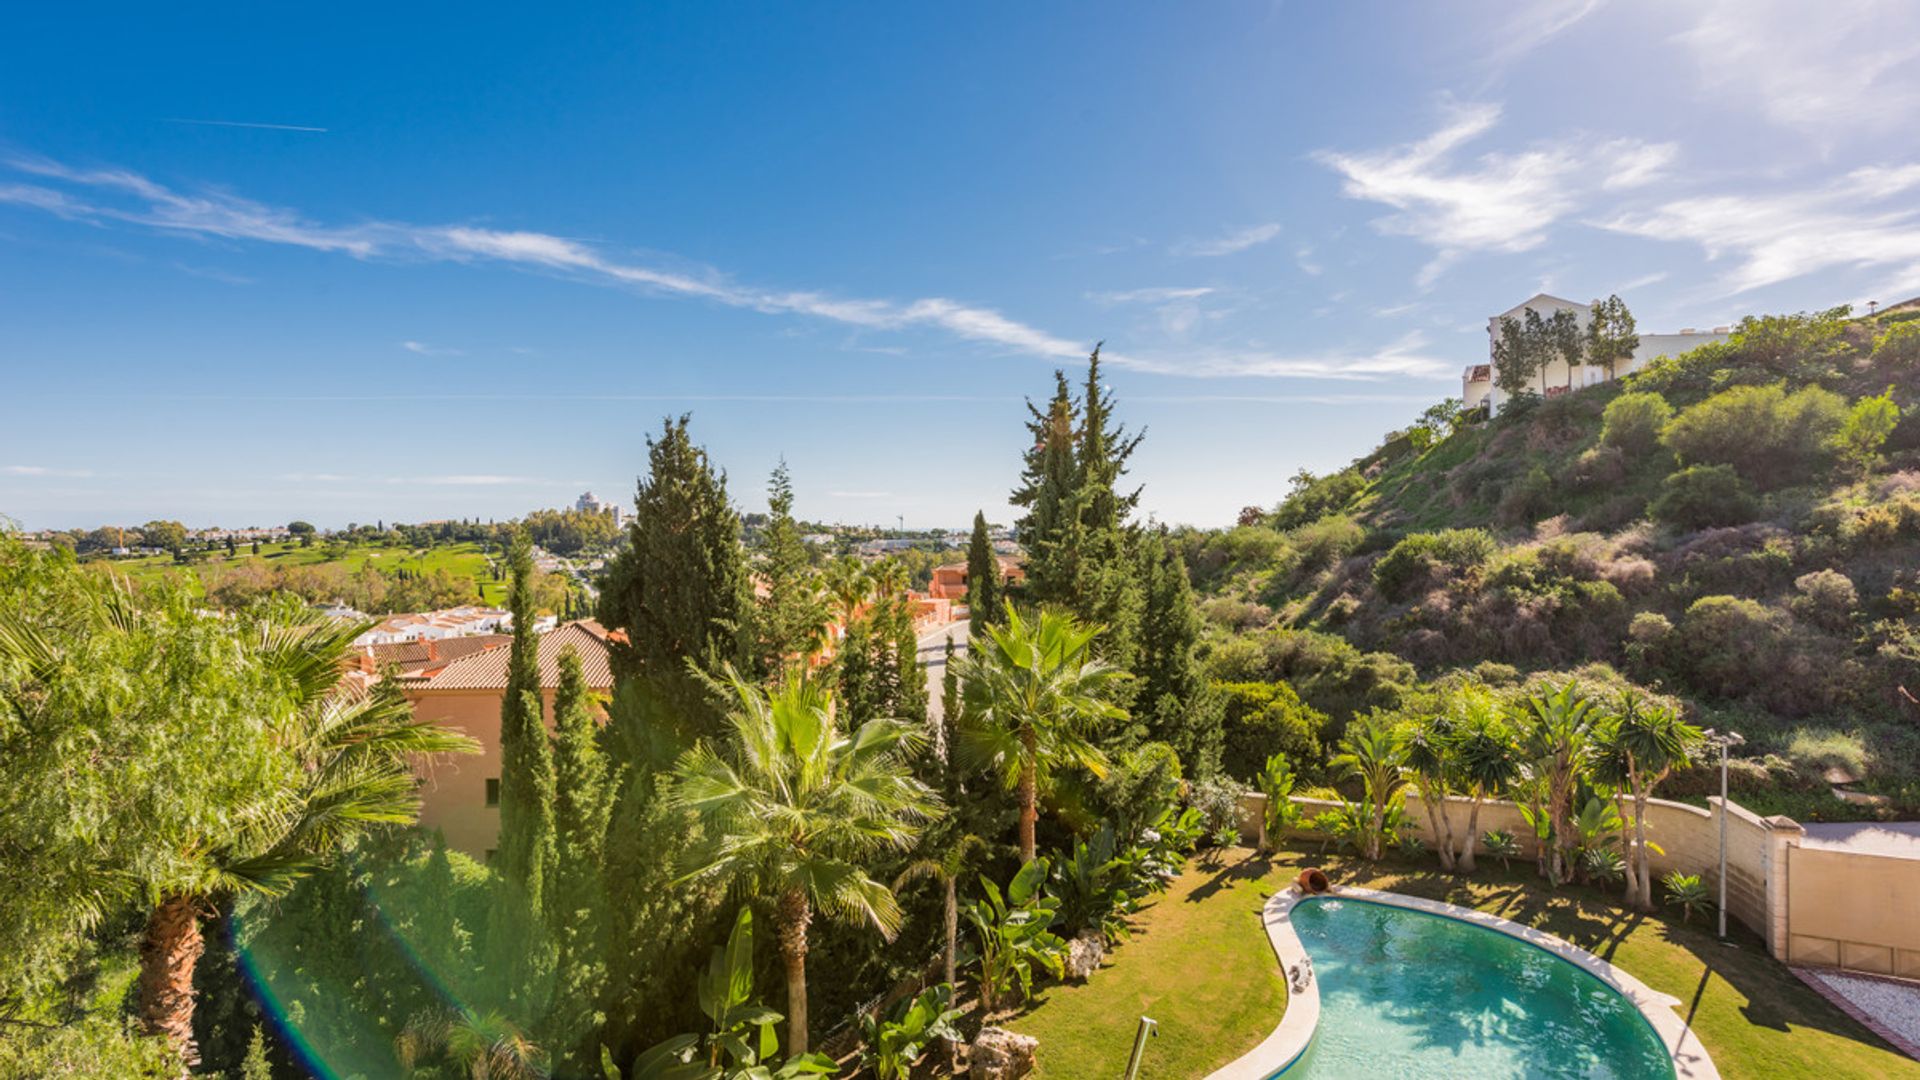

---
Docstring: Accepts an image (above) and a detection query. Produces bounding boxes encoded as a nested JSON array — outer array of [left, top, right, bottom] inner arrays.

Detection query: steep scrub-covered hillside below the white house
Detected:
[[1185, 304, 1920, 819]]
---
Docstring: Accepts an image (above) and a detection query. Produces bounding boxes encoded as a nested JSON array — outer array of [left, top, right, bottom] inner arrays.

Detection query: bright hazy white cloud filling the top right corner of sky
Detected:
[[1678, 0, 1920, 142]]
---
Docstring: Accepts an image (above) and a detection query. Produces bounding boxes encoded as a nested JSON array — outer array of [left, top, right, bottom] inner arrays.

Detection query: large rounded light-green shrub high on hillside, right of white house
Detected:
[[1661, 384, 1847, 478]]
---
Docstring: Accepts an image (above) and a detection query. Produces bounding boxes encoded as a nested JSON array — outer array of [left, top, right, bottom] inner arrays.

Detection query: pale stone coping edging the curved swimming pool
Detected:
[[1208, 886, 1720, 1080]]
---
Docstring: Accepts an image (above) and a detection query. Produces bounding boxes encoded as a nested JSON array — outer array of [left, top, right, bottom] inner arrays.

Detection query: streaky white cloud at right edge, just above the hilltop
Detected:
[[1601, 165, 1920, 294]]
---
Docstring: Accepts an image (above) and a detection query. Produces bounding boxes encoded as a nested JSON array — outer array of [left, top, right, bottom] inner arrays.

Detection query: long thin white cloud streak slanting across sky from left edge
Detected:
[[0, 158, 1436, 379]]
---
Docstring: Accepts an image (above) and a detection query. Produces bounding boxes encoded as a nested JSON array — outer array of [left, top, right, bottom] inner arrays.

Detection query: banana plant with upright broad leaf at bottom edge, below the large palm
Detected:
[[633, 907, 835, 1080]]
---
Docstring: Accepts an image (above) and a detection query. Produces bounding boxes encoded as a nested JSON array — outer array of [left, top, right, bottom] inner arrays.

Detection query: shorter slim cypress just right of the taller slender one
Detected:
[[545, 648, 612, 1074]]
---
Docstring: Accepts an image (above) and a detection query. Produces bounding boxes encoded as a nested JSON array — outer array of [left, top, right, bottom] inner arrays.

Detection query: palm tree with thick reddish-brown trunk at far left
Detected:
[[0, 595, 478, 1067]]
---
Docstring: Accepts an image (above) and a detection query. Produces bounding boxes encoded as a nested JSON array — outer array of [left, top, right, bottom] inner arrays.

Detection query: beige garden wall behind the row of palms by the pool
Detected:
[[1240, 792, 1797, 963]]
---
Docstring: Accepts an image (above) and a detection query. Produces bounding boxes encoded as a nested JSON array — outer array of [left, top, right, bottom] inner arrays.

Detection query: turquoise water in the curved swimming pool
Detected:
[[1275, 897, 1674, 1080]]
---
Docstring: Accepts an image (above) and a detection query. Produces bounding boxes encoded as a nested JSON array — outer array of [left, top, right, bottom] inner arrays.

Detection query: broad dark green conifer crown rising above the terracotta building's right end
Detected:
[[599, 415, 751, 737]]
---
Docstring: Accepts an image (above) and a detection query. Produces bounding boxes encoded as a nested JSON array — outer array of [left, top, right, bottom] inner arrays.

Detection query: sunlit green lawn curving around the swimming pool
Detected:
[[1004, 849, 1920, 1080]]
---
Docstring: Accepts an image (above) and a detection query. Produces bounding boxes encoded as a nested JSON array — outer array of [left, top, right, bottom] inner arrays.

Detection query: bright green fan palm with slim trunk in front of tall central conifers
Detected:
[[962, 603, 1125, 863]]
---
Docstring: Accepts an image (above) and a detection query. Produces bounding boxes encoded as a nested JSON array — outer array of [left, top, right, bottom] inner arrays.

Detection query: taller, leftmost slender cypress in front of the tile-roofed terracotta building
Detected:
[[495, 530, 555, 919]]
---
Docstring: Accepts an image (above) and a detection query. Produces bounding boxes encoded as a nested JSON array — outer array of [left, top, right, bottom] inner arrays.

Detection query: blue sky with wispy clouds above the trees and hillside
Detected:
[[0, 0, 1920, 528]]
